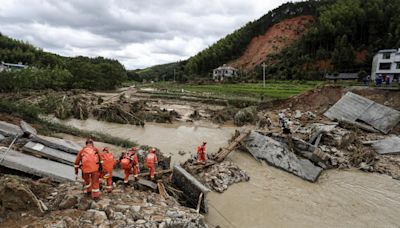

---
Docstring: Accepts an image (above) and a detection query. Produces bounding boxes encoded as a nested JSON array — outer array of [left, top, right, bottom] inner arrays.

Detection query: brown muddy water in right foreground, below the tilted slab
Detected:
[[206, 152, 400, 227]]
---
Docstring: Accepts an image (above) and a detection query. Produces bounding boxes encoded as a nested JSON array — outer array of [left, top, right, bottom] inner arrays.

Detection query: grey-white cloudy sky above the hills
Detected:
[[0, 0, 289, 69]]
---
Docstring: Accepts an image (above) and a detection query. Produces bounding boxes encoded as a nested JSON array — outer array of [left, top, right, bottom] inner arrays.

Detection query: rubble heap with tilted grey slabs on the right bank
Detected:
[[241, 92, 400, 182]]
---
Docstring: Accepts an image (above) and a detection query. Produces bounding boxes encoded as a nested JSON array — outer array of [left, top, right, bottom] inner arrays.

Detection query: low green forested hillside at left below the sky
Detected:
[[0, 34, 126, 92]]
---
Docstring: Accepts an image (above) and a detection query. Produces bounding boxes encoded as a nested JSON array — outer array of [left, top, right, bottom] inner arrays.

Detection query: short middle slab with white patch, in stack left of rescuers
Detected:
[[22, 142, 76, 165]]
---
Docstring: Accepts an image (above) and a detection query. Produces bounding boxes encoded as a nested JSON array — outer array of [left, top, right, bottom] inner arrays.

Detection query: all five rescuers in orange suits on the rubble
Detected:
[[74, 139, 207, 199]]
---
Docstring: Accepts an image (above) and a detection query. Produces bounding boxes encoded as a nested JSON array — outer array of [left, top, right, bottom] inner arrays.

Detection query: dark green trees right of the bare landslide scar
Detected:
[[267, 0, 400, 79]]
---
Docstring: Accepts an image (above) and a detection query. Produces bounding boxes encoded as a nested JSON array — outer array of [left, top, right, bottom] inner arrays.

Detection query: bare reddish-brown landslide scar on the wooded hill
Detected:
[[229, 16, 314, 71]]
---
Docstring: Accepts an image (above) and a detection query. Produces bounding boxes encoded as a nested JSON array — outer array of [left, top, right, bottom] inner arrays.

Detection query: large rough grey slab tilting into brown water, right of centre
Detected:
[[244, 131, 323, 182]]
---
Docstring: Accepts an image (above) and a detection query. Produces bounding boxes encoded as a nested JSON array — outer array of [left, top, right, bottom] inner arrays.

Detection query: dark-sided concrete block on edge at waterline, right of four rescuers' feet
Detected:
[[172, 165, 210, 213]]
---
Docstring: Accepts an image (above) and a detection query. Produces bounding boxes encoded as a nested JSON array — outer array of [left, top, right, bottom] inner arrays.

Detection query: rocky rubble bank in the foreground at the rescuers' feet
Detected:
[[0, 175, 207, 228]]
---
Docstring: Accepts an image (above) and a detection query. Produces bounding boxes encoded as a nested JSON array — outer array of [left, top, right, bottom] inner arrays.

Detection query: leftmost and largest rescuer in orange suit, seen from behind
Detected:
[[75, 139, 102, 199]]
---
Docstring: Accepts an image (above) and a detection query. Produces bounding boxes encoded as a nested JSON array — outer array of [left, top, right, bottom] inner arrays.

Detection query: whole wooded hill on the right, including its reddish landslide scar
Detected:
[[139, 0, 400, 79]]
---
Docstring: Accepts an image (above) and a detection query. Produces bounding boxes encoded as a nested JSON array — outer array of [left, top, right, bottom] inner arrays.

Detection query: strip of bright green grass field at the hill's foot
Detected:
[[136, 81, 323, 100]]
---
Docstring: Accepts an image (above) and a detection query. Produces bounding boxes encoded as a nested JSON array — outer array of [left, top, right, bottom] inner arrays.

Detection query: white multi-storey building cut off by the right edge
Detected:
[[371, 48, 400, 80]]
